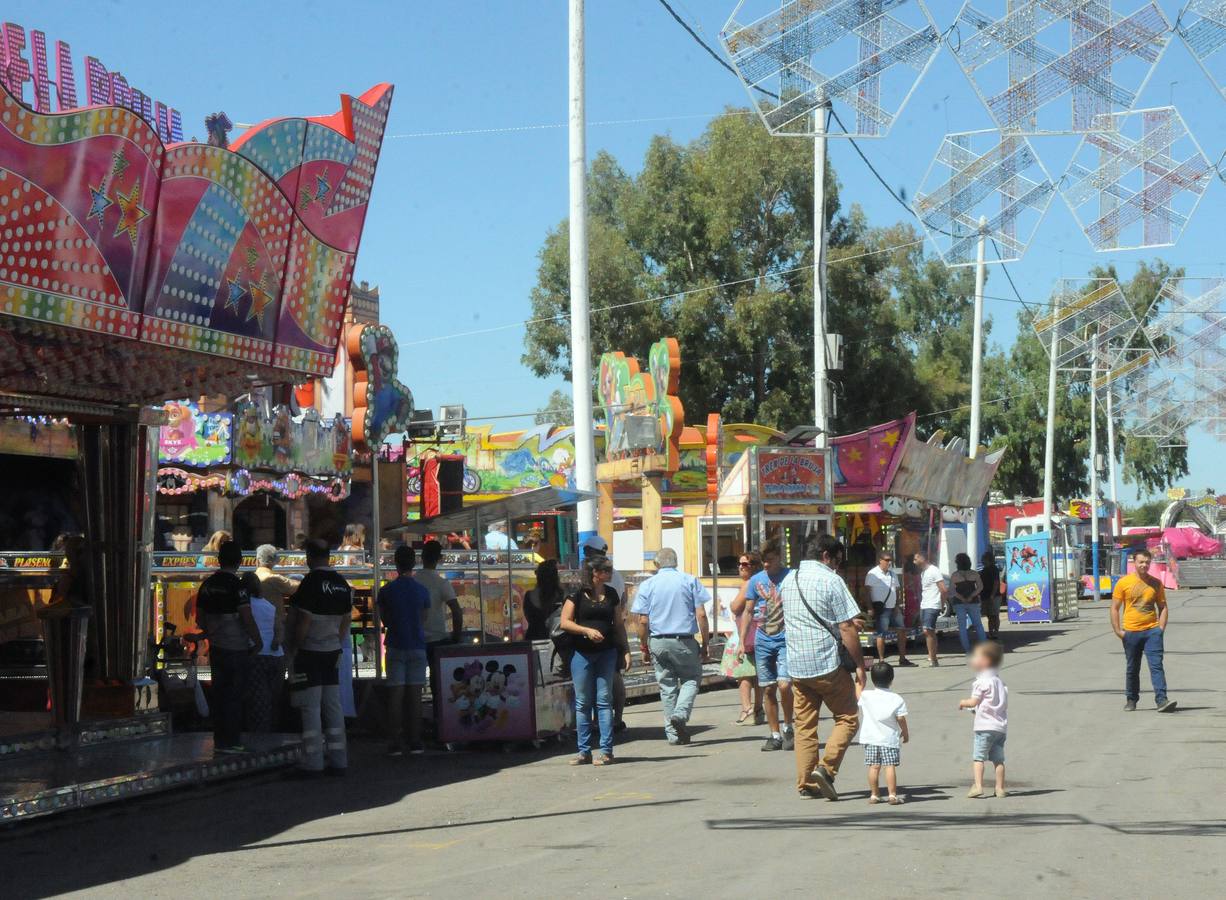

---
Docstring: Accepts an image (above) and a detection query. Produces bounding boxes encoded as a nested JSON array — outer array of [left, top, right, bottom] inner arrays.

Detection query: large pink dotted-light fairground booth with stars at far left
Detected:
[[0, 75, 392, 819]]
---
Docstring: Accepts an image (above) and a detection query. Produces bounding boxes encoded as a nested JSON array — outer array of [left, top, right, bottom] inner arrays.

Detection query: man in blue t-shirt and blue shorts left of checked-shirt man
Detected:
[[732, 541, 796, 750]]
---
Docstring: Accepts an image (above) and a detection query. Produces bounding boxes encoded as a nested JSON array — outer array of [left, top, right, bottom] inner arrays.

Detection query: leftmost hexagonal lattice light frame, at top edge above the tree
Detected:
[[720, 0, 940, 137]]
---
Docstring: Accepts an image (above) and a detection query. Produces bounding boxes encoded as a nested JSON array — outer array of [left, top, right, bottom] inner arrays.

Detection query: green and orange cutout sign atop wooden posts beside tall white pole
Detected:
[[598, 337, 685, 472]]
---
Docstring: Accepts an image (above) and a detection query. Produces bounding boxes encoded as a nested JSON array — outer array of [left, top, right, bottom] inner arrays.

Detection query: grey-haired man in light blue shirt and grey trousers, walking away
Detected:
[[630, 547, 711, 744]]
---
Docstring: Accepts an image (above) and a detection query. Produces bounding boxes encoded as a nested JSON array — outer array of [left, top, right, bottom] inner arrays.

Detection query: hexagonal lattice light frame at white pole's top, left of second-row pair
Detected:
[[911, 130, 1056, 266]]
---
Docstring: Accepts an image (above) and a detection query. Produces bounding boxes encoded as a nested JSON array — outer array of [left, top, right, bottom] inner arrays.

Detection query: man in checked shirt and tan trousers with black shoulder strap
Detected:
[[780, 535, 864, 799]]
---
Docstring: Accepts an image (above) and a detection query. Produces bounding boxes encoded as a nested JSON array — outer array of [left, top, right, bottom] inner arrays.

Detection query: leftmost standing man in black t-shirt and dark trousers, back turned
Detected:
[[196, 541, 264, 753]]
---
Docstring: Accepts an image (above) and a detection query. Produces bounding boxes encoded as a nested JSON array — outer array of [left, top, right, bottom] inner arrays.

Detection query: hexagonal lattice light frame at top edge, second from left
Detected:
[[946, 0, 1171, 134]]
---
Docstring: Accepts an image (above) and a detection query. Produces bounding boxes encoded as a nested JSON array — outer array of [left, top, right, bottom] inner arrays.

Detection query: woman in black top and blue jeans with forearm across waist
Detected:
[[562, 557, 630, 765]]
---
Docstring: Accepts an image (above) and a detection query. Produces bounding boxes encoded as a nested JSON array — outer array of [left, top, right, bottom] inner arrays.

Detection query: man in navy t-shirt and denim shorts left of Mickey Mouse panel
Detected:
[[379, 544, 430, 757]]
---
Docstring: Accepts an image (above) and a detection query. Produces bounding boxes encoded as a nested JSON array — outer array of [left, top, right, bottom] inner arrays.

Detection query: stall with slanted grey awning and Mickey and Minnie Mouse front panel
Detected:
[[385, 487, 596, 744]]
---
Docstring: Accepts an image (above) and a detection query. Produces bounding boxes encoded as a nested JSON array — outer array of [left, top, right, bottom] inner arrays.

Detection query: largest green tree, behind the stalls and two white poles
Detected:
[[524, 110, 973, 432]]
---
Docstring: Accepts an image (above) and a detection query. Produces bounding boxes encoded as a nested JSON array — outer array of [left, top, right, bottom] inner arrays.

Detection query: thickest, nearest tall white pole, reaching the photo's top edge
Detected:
[[570, 0, 596, 542]]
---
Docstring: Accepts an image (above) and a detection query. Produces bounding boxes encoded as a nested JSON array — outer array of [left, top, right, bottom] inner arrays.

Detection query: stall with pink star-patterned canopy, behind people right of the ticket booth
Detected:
[[830, 413, 1004, 645]]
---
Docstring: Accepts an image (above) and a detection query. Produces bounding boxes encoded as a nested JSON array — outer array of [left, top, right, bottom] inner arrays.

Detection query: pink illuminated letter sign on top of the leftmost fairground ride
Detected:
[[0, 22, 183, 143]]
